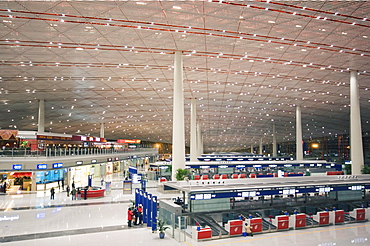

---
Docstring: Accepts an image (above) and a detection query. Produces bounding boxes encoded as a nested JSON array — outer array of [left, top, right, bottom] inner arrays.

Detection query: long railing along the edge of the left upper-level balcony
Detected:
[[0, 148, 157, 158]]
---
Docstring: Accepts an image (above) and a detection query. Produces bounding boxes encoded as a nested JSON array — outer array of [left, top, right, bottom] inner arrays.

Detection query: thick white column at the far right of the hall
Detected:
[[350, 71, 364, 175]]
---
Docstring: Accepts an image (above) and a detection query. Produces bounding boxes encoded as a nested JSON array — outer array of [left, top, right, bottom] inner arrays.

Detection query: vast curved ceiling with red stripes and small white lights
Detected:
[[0, 1, 370, 151]]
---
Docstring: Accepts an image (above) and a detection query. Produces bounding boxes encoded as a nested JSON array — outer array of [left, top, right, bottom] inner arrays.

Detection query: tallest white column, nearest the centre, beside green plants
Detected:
[[172, 51, 185, 181]]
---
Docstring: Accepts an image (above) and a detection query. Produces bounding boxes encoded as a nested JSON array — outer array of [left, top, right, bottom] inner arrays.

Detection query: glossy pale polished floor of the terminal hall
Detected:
[[0, 177, 370, 246]]
